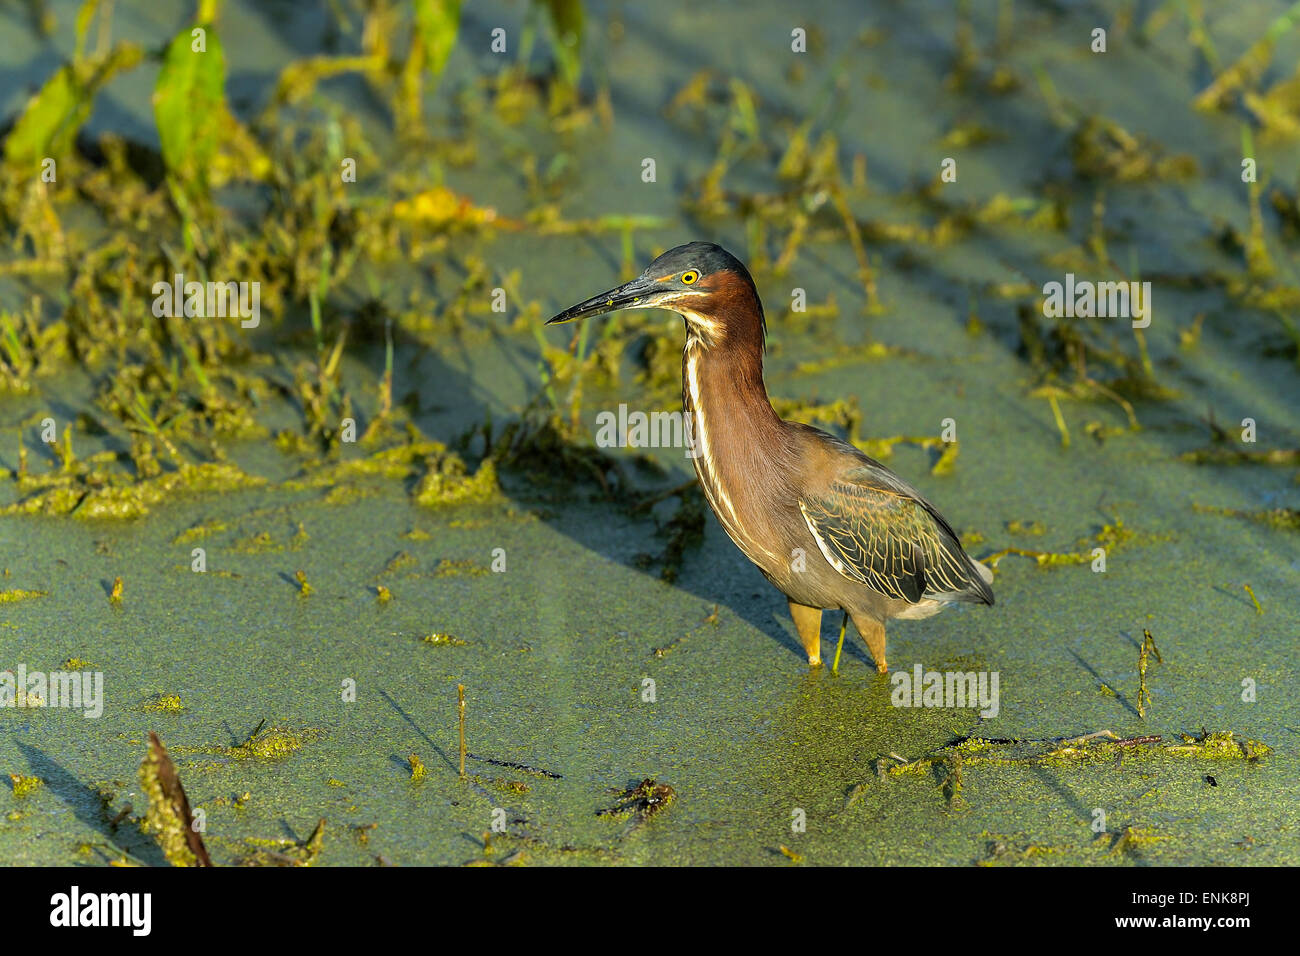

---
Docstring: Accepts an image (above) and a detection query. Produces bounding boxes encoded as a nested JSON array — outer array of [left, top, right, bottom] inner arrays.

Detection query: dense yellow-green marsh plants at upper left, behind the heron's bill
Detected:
[[0, 0, 640, 519]]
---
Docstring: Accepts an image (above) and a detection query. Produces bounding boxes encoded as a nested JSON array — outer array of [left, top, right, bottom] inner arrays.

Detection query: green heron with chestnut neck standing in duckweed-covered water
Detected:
[[546, 242, 993, 674]]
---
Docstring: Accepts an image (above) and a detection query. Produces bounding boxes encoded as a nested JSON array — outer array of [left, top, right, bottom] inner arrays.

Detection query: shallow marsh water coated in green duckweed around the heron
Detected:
[[0, 3, 1300, 865]]
